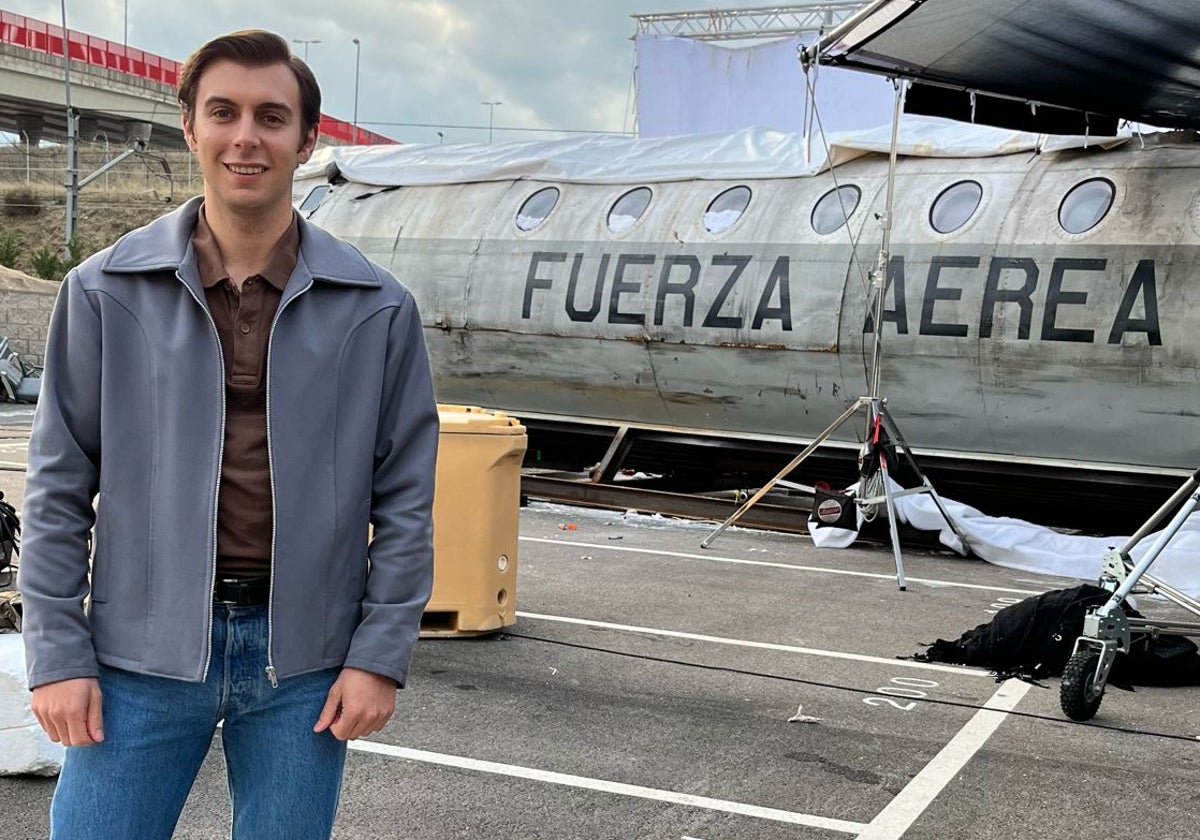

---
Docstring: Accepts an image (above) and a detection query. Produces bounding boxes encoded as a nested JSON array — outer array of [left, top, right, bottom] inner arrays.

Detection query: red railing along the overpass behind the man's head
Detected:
[[0, 10, 396, 145]]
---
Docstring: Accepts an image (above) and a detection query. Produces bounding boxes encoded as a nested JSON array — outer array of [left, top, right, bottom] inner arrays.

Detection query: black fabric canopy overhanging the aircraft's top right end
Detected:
[[817, 0, 1200, 134]]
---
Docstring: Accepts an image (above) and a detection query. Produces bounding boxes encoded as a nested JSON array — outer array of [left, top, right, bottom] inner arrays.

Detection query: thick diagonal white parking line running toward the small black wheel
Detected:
[[858, 679, 1030, 840]]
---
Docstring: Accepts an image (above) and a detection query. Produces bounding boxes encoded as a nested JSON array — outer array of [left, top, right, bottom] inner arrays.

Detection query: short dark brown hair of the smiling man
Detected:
[[179, 29, 320, 138]]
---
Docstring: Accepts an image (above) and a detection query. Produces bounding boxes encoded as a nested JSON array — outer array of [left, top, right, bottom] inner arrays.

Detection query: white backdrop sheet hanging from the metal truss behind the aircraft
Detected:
[[634, 35, 895, 137]]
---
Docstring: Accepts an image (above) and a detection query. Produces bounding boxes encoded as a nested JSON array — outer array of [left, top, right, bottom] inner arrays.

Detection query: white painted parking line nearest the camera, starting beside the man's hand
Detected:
[[349, 740, 866, 834]]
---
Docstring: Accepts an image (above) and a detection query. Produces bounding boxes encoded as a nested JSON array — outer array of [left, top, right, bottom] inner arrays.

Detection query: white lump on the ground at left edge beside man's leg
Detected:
[[0, 632, 66, 776]]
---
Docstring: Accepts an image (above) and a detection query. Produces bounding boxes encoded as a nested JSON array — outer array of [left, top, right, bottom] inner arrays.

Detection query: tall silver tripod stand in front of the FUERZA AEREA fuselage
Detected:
[[700, 80, 967, 590]]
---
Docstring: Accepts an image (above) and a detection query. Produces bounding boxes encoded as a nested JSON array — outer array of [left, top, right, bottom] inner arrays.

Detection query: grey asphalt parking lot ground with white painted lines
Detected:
[[0, 416, 1200, 840]]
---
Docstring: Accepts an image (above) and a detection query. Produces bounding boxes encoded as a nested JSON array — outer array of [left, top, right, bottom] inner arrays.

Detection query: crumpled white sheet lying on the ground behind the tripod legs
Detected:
[[810, 482, 1200, 598]]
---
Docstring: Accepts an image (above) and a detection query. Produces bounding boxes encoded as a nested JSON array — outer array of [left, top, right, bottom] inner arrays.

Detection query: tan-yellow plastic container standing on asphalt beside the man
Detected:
[[421, 406, 527, 636]]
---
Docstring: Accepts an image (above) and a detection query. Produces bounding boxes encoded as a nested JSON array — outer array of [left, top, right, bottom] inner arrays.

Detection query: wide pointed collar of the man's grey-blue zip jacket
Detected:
[[101, 196, 382, 288]]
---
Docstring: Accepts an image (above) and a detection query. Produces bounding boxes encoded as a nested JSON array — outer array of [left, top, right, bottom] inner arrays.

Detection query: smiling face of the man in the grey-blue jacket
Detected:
[[184, 60, 317, 217]]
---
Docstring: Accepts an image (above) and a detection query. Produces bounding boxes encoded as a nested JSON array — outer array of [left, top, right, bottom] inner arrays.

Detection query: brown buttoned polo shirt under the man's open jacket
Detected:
[[192, 208, 300, 580]]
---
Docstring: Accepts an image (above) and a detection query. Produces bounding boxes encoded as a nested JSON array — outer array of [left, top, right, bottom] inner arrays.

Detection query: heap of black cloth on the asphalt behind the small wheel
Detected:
[[913, 583, 1200, 685]]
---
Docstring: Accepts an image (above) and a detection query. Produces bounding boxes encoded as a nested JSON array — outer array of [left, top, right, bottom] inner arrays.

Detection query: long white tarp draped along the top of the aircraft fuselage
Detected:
[[295, 116, 1128, 192]]
